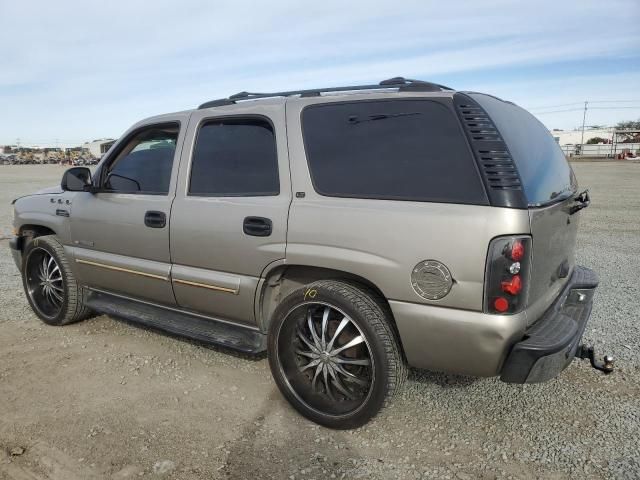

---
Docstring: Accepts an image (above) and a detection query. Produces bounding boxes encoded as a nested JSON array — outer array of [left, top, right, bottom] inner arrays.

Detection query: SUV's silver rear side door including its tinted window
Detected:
[[170, 103, 291, 324]]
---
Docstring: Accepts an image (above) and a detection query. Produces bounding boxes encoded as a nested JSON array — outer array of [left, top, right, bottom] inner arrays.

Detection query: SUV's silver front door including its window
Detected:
[[69, 115, 188, 305]]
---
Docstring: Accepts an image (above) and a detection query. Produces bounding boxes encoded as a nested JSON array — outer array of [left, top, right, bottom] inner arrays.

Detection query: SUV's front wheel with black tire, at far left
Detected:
[[22, 235, 91, 326]]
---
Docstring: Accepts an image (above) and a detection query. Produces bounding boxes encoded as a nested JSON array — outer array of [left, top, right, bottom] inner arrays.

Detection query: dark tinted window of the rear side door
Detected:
[[189, 119, 280, 196]]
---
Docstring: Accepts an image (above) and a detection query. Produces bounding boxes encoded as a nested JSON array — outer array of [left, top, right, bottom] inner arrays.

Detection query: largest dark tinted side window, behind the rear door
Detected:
[[303, 100, 487, 205]]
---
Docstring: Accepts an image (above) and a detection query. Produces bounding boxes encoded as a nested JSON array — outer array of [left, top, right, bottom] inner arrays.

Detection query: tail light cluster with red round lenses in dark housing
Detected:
[[484, 236, 531, 314]]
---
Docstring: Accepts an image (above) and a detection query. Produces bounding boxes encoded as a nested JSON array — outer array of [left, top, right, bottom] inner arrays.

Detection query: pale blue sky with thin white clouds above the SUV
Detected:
[[0, 0, 640, 146]]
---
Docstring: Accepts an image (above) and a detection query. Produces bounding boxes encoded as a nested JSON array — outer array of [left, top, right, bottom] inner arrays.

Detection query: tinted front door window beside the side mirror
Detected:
[[104, 124, 179, 194]]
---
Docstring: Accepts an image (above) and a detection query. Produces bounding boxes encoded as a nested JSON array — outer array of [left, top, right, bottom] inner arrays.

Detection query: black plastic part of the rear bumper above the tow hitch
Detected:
[[500, 267, 598, 383]]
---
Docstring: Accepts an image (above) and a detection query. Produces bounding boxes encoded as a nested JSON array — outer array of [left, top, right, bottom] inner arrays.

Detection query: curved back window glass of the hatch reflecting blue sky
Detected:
[[471, 94, 577, 205]]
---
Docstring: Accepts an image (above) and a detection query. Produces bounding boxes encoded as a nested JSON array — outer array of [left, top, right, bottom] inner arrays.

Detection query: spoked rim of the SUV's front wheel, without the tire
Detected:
[[25, 248, 65, 318]]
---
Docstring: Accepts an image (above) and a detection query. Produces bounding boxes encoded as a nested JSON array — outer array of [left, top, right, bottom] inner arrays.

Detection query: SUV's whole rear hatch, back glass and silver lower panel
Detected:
[[470, 94, 579, 321]]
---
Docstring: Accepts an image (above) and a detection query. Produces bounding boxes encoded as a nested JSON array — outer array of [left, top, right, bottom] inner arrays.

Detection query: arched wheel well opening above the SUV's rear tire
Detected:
[[256, 265, 402, 348]]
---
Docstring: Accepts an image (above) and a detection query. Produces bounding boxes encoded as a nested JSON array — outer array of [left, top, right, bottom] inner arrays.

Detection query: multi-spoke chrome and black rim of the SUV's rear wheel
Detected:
[[278, 302, 374, 415]]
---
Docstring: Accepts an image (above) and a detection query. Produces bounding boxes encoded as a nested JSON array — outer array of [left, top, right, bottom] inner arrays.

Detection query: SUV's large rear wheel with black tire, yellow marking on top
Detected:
[[267, 280, 407, 429]]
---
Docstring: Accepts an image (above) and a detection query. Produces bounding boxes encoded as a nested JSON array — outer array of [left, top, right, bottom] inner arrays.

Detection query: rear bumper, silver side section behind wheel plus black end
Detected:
[[389, 267, 598, 383]]
